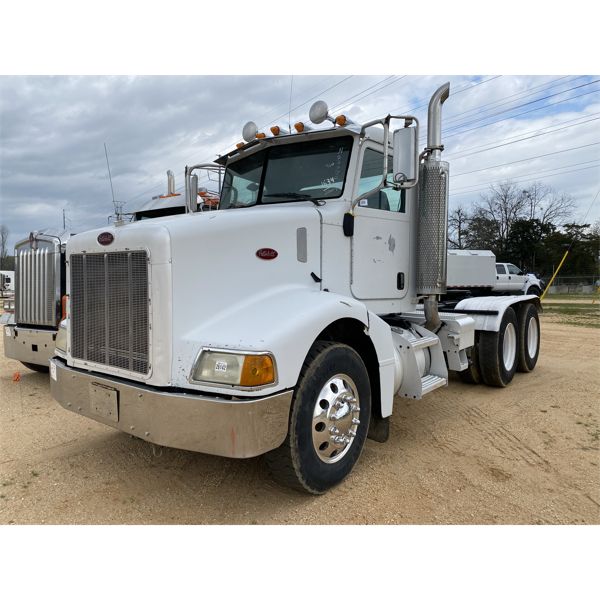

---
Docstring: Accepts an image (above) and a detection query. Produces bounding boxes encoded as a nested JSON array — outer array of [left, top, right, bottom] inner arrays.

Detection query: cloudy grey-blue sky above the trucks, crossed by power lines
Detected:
[[0, 74, 600, 247]]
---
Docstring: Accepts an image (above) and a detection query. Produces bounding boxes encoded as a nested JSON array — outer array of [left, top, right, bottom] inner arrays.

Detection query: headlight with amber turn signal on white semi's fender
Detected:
[[191, 349, 275, 387]]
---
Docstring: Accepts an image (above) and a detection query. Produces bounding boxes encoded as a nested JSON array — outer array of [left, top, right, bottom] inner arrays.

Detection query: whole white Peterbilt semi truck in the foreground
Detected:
[[51, 84, 540, 494]]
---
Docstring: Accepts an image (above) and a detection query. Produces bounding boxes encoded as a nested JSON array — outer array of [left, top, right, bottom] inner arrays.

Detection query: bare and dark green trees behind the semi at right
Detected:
[[448, 181, 600, 277]]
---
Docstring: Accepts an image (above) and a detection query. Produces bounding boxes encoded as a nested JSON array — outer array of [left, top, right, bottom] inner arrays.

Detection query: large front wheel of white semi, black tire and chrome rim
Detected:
[[265, 342, 371, 494]]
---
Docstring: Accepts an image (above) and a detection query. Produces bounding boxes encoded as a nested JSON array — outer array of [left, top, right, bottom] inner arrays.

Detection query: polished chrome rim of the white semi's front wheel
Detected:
[[312, 373, 360, 464]]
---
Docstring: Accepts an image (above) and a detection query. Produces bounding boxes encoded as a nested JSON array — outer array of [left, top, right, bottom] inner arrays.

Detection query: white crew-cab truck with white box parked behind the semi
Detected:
[[447, 250, 545, 296]]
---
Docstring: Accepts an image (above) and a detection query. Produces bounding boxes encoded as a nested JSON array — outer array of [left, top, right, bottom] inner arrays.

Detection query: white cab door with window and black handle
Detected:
[[350, 143, 411, 300]]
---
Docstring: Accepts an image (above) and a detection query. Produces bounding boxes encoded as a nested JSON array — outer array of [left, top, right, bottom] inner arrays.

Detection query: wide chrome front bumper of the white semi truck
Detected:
[[50, 358, 292, 458]]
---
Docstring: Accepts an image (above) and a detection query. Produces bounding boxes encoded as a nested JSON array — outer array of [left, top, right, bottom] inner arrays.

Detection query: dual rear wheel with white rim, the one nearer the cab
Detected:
[[478, 307, 519, 387]]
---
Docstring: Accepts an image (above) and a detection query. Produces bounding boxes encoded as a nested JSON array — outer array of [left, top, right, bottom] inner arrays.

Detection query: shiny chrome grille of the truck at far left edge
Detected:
[[15, 241, 60, 327]]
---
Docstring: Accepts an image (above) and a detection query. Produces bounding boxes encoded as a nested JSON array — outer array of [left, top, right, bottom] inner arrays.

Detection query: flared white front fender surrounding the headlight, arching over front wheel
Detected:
[[172, 286, 369, 397]]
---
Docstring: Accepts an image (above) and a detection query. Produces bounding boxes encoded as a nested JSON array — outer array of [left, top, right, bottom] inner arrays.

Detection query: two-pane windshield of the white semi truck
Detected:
[[219, 136, 352, 209]]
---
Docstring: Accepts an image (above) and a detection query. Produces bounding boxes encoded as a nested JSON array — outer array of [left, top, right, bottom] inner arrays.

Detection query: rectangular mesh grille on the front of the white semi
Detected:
[[69, 251, 150, 374]]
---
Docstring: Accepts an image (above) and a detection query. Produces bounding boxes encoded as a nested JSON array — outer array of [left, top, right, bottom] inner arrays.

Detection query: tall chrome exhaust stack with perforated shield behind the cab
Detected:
[[417, 83, 450, 331]]
